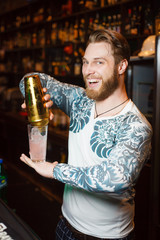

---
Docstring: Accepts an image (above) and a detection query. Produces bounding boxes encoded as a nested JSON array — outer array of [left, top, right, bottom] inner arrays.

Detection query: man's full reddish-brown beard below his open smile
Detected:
[[85, 68, 119, 101]]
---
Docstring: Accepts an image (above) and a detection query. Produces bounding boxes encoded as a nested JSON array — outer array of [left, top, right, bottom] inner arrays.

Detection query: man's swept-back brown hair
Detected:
[[87, 29, 130, 64]]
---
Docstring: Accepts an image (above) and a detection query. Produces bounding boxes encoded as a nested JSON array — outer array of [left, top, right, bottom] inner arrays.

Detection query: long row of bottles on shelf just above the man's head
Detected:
[[1, 5, 154, 50]]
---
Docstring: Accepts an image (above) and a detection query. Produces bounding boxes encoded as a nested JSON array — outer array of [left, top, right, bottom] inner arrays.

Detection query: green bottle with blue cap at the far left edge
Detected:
[[0, 158, 7, 203]]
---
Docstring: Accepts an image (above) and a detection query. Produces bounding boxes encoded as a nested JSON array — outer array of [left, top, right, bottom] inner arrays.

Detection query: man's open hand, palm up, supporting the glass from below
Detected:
[[20, 154, 58, 178]]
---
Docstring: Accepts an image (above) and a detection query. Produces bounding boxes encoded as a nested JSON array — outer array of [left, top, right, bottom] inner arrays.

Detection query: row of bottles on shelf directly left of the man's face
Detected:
[[0, 43, 84, 76]]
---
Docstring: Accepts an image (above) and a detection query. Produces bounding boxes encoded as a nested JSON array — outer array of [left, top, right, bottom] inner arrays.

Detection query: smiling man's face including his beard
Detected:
[[82, 42, 118, 101]]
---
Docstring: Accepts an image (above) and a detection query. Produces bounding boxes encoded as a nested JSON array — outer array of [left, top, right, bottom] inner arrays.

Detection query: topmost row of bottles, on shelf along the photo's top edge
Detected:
[[0, 0, 125, 32]]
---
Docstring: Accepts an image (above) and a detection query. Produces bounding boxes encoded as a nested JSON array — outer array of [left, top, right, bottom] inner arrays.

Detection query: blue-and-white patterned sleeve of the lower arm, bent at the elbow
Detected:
[[53, 115, 152, 193]]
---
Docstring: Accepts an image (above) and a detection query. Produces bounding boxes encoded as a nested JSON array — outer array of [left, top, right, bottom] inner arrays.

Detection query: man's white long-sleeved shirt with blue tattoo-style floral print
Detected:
[[20, 74, 152, 239]]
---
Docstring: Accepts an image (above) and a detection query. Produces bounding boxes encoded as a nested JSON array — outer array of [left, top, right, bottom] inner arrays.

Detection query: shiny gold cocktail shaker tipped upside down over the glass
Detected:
[[24, 74, 49, 127]]
